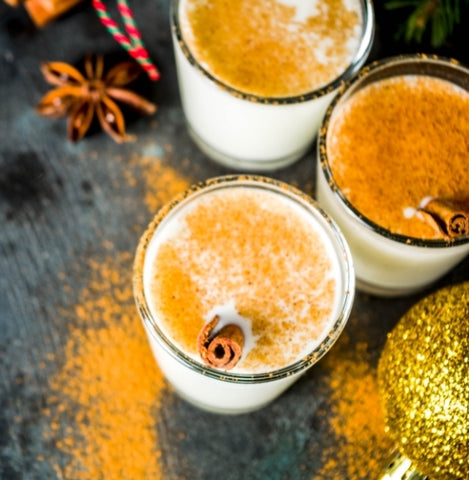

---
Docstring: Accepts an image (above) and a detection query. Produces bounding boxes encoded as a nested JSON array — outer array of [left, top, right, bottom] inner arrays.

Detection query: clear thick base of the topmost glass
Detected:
[[187, 123, 309, 172]]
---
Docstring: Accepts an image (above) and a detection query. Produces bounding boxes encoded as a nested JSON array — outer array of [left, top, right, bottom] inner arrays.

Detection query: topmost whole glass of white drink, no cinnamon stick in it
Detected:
[[171, 0, 374, 170]]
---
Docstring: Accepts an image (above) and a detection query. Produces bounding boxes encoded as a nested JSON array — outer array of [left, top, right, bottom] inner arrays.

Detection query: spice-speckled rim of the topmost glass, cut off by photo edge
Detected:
[[170, 0, 375, 105]]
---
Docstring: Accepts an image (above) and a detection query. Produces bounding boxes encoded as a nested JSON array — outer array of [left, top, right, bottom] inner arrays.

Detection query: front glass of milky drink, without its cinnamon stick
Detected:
[[134, 176, 354, 413]]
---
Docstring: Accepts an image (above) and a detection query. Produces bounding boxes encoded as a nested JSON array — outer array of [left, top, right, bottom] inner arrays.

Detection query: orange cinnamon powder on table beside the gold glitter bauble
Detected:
[[313, 334, 393, 480]]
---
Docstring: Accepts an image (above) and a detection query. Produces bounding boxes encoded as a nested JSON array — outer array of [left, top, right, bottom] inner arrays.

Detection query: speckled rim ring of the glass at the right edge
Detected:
[[317, 53, 469, 248]]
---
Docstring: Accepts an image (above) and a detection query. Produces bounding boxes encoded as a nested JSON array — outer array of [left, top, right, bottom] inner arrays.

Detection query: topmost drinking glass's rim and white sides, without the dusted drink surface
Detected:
[[170, 0, 375, 171]]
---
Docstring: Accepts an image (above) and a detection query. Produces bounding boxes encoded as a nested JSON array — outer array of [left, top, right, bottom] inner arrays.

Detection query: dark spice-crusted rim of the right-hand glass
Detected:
[[317, 53, 469, 248]]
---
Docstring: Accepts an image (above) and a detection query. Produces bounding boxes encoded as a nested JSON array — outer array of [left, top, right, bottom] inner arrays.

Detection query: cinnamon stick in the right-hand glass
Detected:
[[419, 198, 469, 237]]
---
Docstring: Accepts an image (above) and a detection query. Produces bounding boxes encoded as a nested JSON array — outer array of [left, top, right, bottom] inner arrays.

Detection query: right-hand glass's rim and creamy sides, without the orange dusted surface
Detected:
[[317, 55, 469, 296]]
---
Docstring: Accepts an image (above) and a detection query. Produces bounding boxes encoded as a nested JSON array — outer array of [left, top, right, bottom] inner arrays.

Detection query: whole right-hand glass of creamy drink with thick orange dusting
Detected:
[[317, 55, 469, 296]]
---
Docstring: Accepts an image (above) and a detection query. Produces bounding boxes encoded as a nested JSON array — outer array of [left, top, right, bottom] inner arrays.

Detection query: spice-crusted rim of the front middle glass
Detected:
[[133, 174, 355, 383]]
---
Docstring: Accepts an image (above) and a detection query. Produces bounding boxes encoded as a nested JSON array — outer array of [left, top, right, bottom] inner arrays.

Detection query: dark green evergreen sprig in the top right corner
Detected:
[[385, 0, 469, 48]]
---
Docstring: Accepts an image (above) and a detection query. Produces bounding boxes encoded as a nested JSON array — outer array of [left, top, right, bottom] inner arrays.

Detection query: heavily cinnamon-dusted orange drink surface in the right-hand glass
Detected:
[[327, 75, 469, 239]]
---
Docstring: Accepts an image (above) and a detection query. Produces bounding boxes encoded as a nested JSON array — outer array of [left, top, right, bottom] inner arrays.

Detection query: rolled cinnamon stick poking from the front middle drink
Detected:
[[197, 315, 244, 370]]
